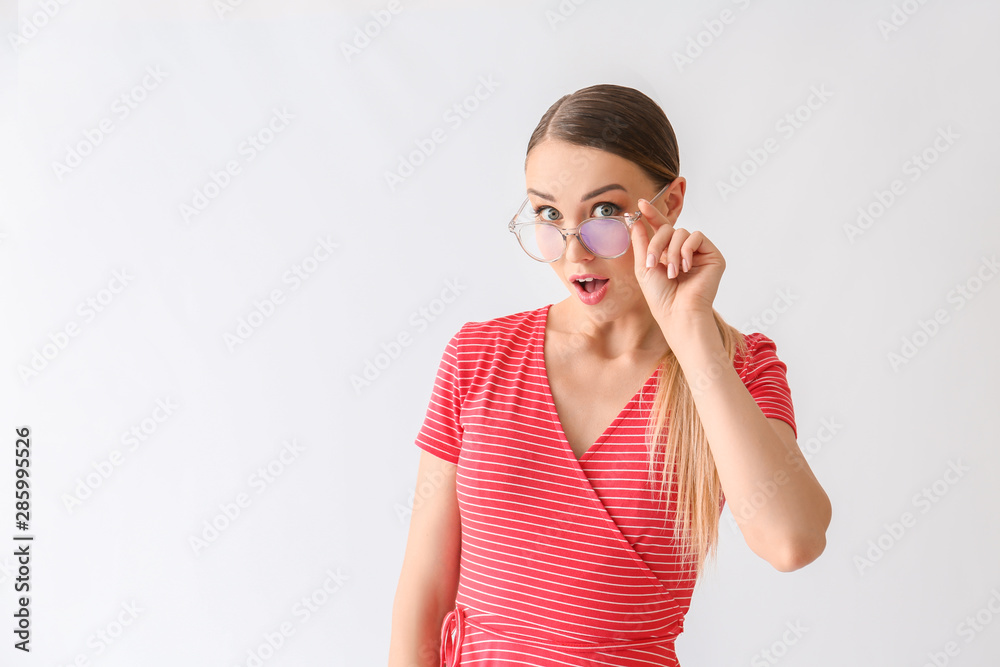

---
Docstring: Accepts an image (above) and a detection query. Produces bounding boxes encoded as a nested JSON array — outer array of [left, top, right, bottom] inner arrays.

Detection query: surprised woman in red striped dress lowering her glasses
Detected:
[[389, 85, 831, 667]]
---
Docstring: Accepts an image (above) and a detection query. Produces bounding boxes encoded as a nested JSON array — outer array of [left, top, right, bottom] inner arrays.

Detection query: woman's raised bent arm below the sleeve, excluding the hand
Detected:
[[670, 315, 832, 572]]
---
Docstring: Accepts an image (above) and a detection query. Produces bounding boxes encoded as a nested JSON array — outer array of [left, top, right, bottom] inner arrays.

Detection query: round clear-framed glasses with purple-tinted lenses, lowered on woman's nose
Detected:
[[507, 181, 673, 263]]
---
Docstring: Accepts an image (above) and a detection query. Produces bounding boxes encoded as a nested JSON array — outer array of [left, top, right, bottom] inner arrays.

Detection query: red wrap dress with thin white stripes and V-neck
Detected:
[[416, 304, 795, 667]]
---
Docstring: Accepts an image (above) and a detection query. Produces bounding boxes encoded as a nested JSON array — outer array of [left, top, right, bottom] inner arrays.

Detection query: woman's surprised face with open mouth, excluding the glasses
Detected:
[[525, 139, 674, 319]]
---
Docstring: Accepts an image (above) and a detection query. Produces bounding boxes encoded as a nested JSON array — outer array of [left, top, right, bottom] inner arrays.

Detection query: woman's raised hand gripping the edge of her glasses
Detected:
[[631, 199, 726, 332]]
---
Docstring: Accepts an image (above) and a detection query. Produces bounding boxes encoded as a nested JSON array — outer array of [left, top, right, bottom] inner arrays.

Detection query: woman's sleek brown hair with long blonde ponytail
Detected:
[[525, 84, 746, 577]]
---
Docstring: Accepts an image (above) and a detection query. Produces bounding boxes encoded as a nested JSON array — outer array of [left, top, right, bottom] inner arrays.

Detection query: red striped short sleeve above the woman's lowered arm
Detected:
[[416, 326, 465, 465]]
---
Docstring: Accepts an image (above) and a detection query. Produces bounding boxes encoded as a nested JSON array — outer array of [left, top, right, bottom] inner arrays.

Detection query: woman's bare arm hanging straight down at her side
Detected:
[[389, 451, 462, 667]]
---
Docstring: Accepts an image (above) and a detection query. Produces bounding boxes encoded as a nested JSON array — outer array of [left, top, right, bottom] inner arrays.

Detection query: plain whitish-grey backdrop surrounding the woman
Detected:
[[0, 0, 1000, 667]]
